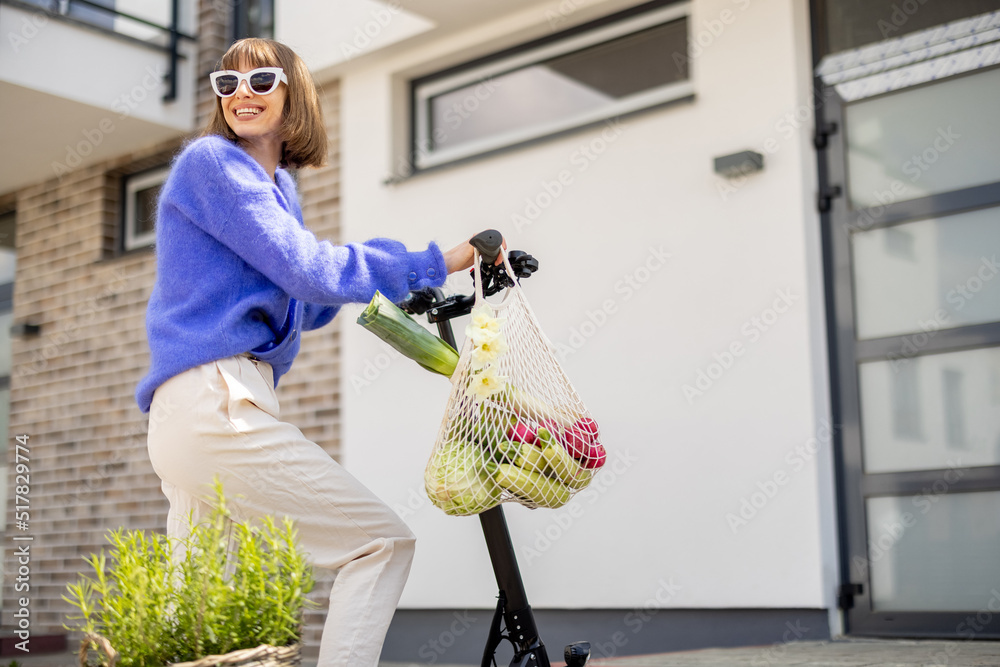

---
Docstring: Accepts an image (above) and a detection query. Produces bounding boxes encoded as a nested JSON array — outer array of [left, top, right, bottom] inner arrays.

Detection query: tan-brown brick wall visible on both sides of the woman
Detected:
[[3, 0, 340, 655]]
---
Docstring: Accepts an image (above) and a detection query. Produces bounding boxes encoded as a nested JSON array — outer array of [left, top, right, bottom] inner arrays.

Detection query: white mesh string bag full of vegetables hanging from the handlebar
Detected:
[[424, 252, 607, 516]]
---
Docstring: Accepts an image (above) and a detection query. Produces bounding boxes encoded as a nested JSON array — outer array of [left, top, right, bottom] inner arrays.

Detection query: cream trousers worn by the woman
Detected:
[[148, 355, 415, 667]]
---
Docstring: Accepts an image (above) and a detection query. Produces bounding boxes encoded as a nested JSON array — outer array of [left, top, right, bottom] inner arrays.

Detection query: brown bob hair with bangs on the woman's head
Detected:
[[203, 37, 328, 168]]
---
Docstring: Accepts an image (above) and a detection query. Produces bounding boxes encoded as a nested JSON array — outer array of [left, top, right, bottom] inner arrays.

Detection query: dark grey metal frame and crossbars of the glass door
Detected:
[[814, 70, 1000, 639]]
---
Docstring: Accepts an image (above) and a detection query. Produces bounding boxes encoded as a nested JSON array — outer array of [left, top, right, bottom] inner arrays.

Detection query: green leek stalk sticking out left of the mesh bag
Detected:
[[358, 292, 458, 377]]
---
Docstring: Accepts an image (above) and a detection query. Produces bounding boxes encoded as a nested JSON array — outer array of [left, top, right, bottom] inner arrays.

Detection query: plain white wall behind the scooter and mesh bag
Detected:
[[328, 0, 836, 608]]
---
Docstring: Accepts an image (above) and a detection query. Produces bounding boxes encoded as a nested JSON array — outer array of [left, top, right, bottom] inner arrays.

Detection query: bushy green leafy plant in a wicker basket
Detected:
[[63, 481, 315, 667]]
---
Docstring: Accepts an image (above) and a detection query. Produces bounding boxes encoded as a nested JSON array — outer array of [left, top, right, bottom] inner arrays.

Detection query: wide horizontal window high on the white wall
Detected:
[[411, 2, 694, 170]]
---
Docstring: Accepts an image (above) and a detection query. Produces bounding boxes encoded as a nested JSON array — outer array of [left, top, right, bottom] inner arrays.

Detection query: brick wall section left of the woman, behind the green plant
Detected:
[[4, 138, 176, 634]]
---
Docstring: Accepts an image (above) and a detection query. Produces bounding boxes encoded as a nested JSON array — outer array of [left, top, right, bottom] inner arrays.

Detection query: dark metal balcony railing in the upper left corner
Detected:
[[0, 0, 196, 102]]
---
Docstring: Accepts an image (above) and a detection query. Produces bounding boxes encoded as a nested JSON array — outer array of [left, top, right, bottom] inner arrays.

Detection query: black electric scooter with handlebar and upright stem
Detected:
[[399, 229, 590, 667]]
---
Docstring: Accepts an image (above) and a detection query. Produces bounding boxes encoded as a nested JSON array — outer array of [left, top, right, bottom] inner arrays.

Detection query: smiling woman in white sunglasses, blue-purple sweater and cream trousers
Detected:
[[136, 39, 496, 667]]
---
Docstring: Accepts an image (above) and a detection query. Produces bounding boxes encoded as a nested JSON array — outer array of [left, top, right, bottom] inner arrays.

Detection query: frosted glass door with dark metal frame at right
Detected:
[[821, 68, 1000, 639]]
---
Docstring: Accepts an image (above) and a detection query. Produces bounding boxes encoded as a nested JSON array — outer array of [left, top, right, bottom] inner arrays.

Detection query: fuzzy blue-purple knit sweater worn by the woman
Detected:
[[135, 136, 447, 412]]
